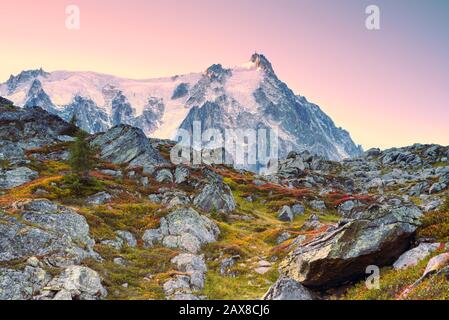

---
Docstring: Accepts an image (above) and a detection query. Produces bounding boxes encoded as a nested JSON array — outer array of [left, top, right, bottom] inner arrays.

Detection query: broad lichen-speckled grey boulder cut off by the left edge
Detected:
[[0, 200, 100, 266]]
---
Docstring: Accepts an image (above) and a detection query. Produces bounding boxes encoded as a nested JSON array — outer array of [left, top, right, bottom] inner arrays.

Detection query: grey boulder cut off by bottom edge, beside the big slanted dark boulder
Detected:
[[263, 276, 317, 300]]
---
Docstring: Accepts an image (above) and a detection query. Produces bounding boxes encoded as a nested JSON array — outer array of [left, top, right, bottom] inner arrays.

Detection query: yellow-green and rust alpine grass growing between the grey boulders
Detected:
[[0, 144, 449, 299]]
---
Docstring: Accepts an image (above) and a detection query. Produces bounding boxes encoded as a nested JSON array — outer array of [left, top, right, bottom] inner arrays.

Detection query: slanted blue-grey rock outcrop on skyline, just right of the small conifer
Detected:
[[91, 125, 166, 167]]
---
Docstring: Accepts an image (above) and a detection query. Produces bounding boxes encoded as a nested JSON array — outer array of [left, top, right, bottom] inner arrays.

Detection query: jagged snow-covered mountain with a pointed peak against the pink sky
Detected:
[[0, 54, 362, 160]]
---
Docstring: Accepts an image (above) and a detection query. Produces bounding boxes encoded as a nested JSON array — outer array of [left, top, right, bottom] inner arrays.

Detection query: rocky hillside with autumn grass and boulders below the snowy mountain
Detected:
[[0, 99, 449, 300]]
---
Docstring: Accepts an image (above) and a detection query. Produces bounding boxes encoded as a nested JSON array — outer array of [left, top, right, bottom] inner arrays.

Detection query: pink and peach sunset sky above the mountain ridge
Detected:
[[0, 0, 449, 148]]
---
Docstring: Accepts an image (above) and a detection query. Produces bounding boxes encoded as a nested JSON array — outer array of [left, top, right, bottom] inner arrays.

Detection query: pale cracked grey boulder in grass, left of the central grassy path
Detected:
[[142, 208, 220, 253]]
